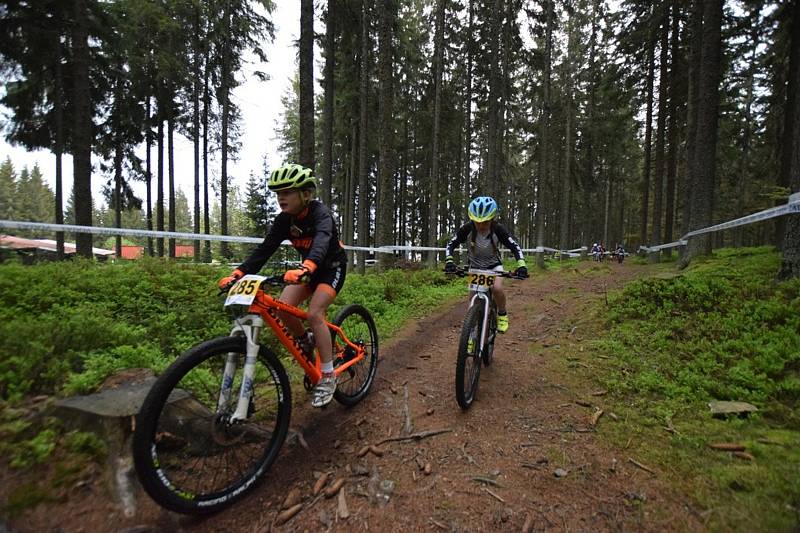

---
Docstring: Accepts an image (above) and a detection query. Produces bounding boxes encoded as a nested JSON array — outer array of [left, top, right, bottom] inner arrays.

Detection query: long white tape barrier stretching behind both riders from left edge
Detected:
[[0, 220, 585, 257]]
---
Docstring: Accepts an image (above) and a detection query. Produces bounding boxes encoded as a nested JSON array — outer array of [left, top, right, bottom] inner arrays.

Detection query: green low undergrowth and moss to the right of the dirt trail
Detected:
[[590, 248, 800, 531]]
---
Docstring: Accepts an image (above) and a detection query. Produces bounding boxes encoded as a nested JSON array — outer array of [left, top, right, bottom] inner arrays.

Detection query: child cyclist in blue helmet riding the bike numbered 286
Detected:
[[444, 196, 528, 333]]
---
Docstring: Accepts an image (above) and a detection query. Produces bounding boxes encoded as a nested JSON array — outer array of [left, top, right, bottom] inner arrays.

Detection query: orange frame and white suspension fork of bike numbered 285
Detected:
[[222, 289, 364, 423]]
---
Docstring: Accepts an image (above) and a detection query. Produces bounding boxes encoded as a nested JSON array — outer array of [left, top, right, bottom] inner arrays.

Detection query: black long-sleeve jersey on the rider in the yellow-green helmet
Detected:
[[239, 200, 347, 274]]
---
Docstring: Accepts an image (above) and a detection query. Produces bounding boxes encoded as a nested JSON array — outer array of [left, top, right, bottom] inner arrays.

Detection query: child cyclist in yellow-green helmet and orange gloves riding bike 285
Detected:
[[219, 164, 347, 407]]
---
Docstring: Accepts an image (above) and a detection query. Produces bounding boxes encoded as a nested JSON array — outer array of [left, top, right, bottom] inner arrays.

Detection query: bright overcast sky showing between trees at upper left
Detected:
[[0, 1, 306, 210]]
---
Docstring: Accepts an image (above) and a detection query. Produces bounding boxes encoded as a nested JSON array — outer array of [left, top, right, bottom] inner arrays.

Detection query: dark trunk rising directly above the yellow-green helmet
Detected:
[[299, 0, 314, 170]]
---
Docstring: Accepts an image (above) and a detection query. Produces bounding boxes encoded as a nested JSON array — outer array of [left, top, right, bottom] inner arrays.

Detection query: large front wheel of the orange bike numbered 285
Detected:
[[133, 337, 292, 514]]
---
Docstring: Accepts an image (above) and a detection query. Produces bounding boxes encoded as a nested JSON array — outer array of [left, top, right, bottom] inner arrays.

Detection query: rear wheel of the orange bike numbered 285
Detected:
[[332, 304, 378, 406]]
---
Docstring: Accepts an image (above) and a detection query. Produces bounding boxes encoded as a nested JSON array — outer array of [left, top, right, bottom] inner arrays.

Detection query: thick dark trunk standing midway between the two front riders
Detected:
[[375, 0, 396, 268]]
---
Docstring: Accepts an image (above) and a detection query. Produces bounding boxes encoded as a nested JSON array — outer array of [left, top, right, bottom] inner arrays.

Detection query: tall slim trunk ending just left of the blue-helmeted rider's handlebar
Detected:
[[427, 0, 446, 268]]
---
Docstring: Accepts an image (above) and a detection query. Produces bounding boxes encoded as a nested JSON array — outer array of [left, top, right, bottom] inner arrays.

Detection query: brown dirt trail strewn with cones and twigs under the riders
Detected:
[[4, 263, 702, 532]]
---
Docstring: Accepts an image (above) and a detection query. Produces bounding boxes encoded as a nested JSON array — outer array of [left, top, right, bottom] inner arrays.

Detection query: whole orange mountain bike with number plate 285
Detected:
[[133, 275, 378, 514]]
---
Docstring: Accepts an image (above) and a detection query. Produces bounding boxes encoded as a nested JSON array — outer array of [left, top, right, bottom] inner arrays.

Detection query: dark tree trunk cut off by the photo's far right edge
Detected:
[[778, 2, 800, 279]]
